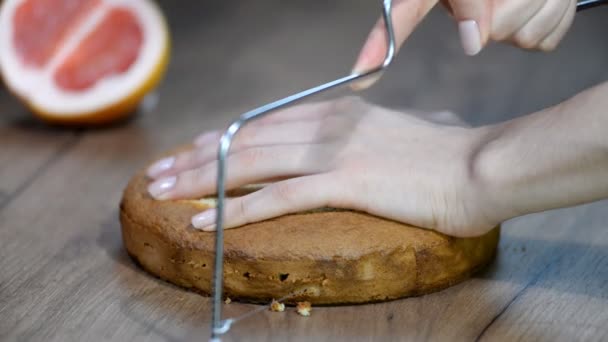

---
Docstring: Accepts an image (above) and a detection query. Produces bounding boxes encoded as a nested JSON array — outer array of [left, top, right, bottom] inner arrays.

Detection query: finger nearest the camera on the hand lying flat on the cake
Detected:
[[192, 175, 348, 231]]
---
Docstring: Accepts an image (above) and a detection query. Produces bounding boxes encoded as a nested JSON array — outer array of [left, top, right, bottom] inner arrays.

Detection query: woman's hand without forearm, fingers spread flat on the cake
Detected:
[[149, 98, 504, 236]]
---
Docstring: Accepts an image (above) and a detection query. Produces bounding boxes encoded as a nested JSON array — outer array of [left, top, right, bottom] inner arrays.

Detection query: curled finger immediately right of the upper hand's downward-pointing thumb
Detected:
[[490, 0, 546, 41]]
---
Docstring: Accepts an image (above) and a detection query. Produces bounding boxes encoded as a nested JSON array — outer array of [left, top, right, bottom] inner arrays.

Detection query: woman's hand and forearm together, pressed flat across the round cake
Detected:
[[148, 83, 608, 236]]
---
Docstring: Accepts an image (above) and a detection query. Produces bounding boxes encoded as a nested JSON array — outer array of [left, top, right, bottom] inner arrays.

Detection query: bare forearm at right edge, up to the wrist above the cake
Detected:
[[472, 83, 608, 218]]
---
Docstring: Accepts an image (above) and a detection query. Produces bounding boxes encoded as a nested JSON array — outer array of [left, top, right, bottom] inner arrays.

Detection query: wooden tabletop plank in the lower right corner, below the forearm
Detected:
[[482, 201, 608, 341]]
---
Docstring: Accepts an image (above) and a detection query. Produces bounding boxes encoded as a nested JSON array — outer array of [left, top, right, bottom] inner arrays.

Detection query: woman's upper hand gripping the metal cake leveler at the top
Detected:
[[353, 0, 576, 90]]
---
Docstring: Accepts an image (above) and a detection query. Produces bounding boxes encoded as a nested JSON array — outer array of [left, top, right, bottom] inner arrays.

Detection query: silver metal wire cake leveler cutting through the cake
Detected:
[[210, 0, 608, 342]]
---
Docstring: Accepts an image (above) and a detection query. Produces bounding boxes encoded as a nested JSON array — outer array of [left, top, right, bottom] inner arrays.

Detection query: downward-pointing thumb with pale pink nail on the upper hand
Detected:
[[448, 0, 492, 56]]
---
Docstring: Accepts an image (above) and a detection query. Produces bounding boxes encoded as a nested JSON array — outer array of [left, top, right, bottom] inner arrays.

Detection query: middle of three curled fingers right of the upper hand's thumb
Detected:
[[512, 0, 573, 49]]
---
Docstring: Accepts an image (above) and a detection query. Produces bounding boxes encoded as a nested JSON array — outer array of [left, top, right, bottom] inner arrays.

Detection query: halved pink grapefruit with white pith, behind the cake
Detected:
[[0, 0, 170, 124]]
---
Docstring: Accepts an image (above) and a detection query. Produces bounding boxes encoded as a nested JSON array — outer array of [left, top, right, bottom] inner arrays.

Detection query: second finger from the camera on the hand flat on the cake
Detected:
[[148, 145, 320, 200]]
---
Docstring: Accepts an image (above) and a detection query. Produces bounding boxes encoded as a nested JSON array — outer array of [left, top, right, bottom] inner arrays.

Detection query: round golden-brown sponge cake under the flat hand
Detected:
[[120, 158, 500, 305]]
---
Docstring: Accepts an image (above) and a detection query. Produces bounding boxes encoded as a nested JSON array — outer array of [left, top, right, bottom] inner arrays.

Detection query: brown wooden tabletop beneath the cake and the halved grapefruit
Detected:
[[0, 0, 608, 341]]
